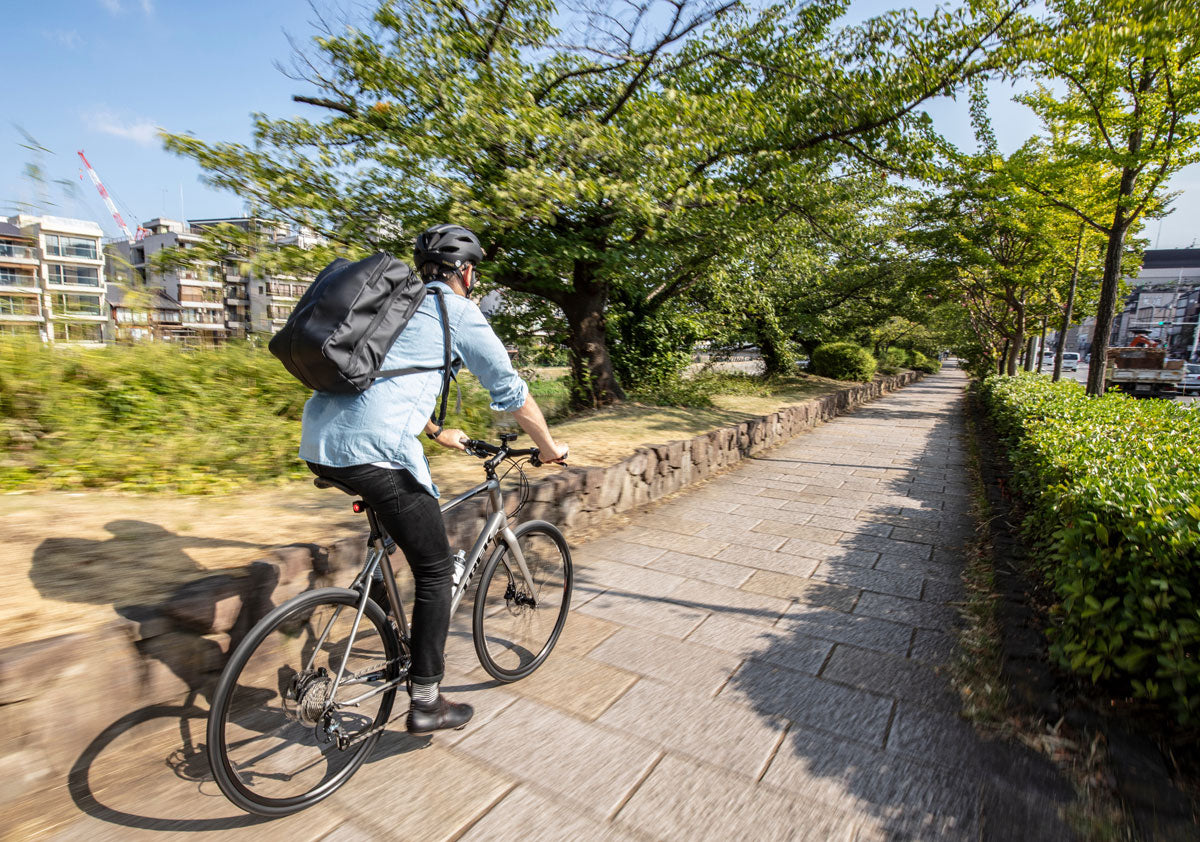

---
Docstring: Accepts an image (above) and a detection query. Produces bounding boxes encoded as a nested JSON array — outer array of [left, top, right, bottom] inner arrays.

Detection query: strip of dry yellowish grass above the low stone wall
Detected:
[[0, 377, 845, 646]]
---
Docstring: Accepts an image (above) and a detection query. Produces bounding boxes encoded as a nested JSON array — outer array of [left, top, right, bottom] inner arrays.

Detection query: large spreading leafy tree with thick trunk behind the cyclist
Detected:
[[167, 0, 1030, 405]]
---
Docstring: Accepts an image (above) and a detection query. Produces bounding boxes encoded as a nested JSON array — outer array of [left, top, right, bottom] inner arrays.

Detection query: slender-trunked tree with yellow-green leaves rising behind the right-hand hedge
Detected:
[[1021, 0, 1200, 395]]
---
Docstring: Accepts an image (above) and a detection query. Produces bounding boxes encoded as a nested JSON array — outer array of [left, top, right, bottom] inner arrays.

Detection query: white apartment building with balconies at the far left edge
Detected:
[[4, 213, 108, 344]]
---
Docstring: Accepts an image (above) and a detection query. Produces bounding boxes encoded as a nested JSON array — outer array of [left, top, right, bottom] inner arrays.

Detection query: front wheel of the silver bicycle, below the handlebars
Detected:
[[472, 521, 574, 684]]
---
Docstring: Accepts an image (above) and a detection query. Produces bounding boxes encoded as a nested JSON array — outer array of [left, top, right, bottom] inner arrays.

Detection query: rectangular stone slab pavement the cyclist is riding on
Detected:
[[18, 368, 1070, 842]]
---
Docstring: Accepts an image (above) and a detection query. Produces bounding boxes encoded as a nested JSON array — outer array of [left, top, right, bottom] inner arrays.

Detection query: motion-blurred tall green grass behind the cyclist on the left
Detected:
[[0, 339, 493, 494]]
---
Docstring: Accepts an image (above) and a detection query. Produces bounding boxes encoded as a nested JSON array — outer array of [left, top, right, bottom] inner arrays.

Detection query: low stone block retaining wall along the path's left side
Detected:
[[0, 372, 922, 806]]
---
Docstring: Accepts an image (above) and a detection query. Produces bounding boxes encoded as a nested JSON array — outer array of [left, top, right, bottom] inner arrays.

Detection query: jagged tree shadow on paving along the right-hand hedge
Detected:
[[722, 367, 1073, 841]]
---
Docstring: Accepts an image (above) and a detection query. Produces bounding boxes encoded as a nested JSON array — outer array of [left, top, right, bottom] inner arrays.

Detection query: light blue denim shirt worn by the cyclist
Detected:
[[300, 282, 529, 497]]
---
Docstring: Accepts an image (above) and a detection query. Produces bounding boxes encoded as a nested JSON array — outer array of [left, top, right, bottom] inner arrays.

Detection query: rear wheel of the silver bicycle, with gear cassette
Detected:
[[208, 588, 401, 816]]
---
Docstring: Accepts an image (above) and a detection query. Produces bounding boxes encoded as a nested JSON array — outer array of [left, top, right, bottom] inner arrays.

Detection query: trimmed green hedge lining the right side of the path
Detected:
[[982, 374, 1200, 723]]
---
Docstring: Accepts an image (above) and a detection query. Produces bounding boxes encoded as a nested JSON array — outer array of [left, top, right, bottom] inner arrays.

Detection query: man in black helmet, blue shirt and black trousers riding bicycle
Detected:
[[300, 224, 568, 734]]
